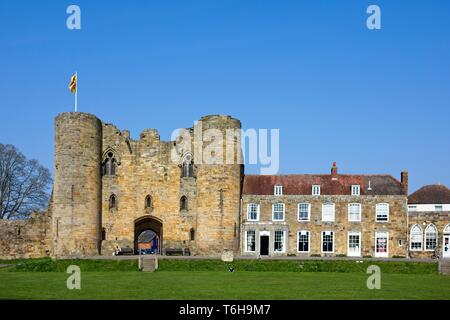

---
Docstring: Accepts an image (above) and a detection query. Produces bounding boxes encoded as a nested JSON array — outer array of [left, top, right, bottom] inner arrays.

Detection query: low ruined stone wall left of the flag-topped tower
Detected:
[[0, 212, 51, 259]]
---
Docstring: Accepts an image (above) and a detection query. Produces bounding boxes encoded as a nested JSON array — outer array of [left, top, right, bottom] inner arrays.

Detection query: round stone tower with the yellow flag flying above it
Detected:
[[52, 112, 102, 257]]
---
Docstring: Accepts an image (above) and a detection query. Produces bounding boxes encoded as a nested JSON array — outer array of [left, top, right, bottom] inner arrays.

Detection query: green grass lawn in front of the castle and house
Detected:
[[0, 261, 450, 300]]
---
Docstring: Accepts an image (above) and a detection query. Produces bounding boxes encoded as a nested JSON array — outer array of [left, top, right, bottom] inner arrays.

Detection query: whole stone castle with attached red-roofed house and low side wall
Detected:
[[0, 112, 450, 258]]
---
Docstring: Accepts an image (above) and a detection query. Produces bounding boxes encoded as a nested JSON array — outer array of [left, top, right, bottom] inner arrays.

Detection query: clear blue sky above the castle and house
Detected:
[[0, 0, 450, 191]]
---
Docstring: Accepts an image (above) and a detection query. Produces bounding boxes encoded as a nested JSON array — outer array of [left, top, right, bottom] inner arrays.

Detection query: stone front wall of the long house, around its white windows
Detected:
[[241, 195, 407, 257]]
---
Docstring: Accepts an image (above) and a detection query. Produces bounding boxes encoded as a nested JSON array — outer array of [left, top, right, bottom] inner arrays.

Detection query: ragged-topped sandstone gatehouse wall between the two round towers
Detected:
[[102, 125, 196, 255]]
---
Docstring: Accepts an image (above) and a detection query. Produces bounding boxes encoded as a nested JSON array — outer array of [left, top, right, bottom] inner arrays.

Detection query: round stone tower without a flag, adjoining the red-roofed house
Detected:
[[194, 115, 243, 254]]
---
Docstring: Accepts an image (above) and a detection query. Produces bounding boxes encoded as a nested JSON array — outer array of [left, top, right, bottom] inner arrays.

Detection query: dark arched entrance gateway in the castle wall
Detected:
[[134, 216, 162, 253]]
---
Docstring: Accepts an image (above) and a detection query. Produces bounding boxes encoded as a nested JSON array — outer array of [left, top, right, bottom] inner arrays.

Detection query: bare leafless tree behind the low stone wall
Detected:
[[0, 143, 52, 219]]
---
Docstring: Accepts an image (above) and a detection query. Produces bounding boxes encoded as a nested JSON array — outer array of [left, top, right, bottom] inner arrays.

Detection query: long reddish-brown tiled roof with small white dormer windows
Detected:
[[243, 174, 406, 196]]
